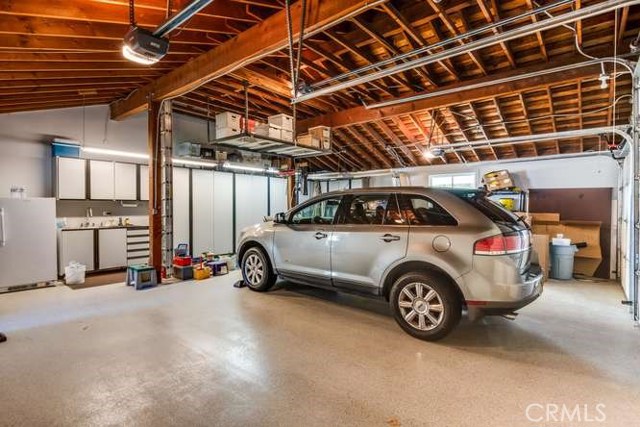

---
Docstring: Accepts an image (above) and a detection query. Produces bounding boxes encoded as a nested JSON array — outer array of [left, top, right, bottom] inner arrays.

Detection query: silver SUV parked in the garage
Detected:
[[238, 187, 542, 340]]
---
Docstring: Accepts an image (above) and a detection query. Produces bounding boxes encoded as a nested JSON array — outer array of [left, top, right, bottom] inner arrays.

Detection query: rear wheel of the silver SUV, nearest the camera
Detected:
[[389, 272, 462, 341]]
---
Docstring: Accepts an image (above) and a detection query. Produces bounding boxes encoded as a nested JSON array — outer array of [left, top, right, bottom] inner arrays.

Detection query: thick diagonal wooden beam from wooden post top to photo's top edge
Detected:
[[111, 0, 382, 119]]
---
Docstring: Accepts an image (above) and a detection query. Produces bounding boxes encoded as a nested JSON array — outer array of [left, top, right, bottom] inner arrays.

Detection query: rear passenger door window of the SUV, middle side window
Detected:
[[338, 194, 402, 225]]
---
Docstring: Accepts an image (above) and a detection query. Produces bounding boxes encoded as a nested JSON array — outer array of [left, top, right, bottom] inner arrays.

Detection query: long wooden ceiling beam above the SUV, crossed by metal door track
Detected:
[[299, 51, 605, 128]]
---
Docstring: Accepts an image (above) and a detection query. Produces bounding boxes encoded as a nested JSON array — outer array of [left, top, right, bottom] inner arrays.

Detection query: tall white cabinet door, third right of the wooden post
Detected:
[[213, 172, 233, 253]]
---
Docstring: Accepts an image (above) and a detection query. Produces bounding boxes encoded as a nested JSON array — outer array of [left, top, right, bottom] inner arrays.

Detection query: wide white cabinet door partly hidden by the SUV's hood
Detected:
[[236, 174, 268, 239]]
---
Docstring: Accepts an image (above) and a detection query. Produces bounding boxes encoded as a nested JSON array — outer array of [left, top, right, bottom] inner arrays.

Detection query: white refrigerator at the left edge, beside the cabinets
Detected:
[[0, 198, 57, 291]]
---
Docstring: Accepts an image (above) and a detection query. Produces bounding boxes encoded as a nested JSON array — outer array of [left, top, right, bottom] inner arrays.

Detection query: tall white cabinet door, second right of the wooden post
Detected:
[[191, 169, 214, 255]]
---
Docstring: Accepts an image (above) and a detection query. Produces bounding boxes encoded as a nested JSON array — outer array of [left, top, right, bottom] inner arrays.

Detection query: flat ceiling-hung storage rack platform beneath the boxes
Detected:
[[209, 133, 331, 158]]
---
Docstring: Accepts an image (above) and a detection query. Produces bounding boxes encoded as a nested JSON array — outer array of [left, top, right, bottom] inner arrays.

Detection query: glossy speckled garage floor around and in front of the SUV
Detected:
[[0, 272, 640, 426]]
